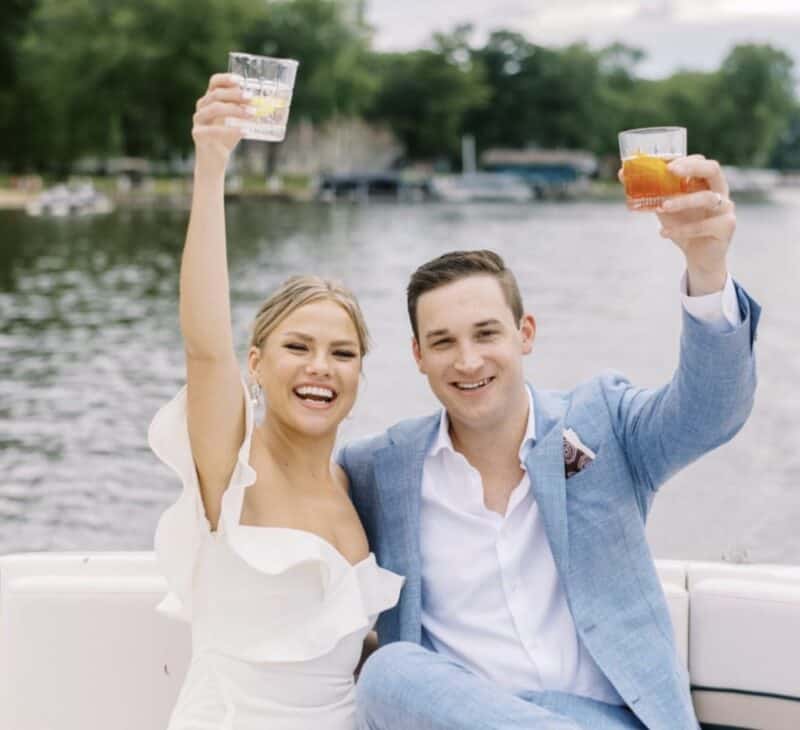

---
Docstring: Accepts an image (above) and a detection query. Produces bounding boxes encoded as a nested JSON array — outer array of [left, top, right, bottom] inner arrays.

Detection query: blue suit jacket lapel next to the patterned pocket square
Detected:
[[525, 389, 569, 585]]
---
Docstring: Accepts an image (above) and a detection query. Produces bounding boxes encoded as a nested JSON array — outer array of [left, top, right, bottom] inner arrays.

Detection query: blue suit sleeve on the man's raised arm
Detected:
[[604, 285, 761, 492]]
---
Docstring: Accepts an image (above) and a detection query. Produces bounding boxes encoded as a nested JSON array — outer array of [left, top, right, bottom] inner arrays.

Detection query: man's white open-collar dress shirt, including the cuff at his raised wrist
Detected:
[[420, 275, 741, 704]]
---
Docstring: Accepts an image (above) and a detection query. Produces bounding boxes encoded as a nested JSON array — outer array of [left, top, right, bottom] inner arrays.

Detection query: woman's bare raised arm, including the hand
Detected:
[[180, 74, 255, 528]]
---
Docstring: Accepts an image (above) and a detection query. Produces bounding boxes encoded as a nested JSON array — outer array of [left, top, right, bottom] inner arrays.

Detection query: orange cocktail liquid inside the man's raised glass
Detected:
[[622, 153, 708, 210]]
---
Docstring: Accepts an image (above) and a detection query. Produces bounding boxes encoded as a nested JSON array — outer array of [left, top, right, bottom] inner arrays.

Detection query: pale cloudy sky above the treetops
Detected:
[[367, 0, 800, 78]]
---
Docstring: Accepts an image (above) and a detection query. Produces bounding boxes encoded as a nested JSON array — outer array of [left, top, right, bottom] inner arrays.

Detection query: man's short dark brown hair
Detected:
[[406, 249, 524, 342]]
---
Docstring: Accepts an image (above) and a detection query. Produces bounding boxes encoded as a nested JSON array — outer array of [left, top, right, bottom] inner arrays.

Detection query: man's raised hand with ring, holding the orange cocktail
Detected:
[[620, 155, 736, 296]]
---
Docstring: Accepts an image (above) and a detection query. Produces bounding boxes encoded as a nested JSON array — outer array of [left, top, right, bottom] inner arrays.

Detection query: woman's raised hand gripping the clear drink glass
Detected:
[[192, 74, 254, 170]]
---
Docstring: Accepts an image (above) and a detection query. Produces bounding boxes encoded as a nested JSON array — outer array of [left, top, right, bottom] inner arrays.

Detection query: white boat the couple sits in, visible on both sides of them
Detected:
[[0, 552, 800, 730]]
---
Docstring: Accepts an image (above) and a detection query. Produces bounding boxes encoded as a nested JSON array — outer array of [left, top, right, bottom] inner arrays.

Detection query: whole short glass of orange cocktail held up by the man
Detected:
[[619, 127, 708, 210]]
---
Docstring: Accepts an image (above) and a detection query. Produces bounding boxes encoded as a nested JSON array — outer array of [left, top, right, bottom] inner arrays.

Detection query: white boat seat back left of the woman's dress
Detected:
[[0, 562, 191, 730]]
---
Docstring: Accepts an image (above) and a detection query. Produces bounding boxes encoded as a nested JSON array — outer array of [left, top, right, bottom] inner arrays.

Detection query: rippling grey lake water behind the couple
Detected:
[[0, 192, 800, 564]]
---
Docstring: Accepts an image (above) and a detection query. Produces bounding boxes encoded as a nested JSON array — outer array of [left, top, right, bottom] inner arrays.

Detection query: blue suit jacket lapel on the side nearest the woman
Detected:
[[375, 415, 439, 643]]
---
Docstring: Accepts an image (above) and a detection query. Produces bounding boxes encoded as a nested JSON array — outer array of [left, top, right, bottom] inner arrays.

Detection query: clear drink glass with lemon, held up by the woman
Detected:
[[225, 53, 298, 142]]
